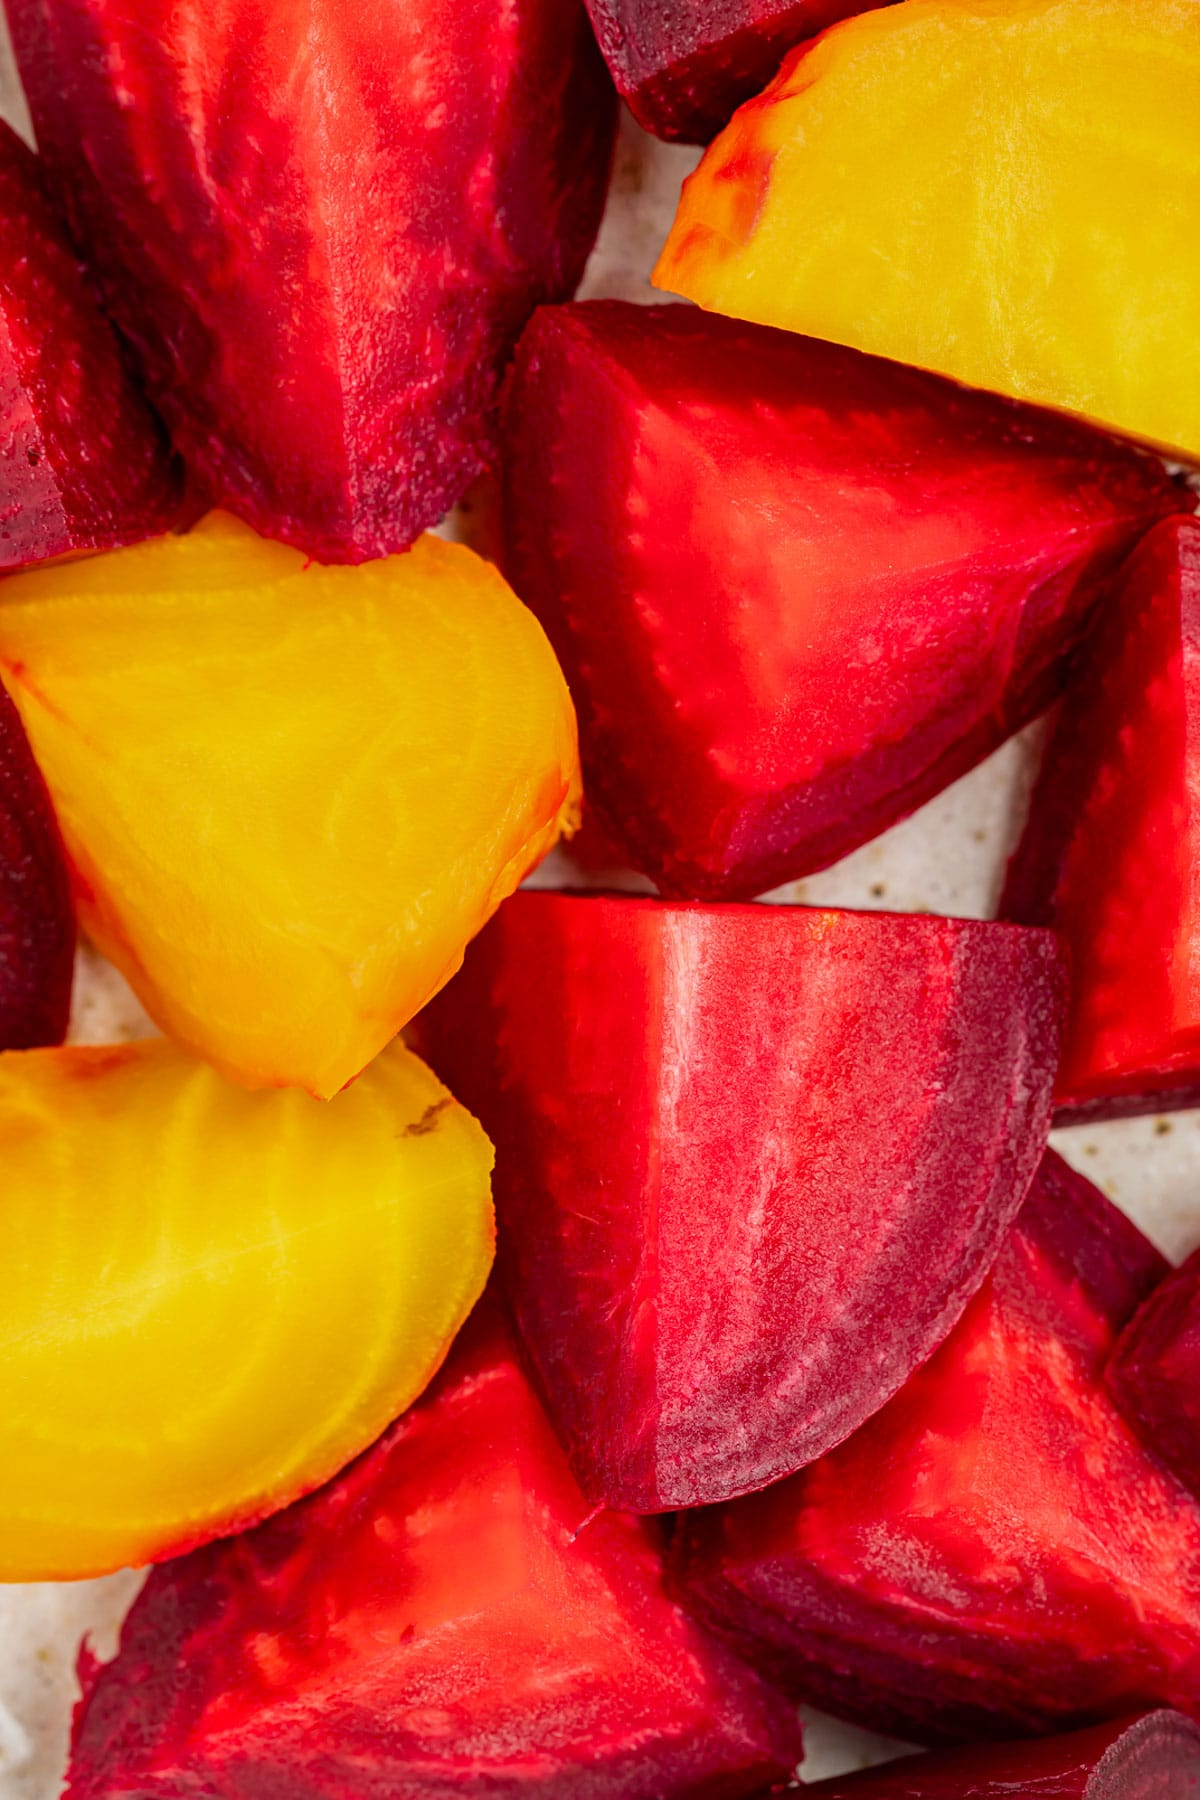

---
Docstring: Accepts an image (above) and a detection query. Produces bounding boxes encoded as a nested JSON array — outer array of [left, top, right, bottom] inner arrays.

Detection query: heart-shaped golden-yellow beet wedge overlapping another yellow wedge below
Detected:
[[0, 515, 579, 1096]]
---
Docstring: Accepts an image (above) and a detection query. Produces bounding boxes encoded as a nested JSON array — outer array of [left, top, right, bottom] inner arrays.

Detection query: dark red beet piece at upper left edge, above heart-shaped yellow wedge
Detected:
[[0, 121, 180, 571]]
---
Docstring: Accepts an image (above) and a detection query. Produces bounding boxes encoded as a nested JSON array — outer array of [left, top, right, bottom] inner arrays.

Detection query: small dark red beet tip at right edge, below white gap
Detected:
[[1108, 1251, 1200, 1494]]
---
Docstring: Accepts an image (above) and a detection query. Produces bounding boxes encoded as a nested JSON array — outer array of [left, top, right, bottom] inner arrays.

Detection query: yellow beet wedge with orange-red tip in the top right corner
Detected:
[[655, 0, 1200, 457]]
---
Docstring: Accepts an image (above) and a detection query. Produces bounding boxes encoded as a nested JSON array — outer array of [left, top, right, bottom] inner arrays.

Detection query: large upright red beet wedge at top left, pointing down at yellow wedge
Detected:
[[5, 0, 615, 562]]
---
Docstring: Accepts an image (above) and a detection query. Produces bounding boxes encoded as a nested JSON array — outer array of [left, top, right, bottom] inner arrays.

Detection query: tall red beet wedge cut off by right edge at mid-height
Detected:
[[1002, 518, 1200, 1121]]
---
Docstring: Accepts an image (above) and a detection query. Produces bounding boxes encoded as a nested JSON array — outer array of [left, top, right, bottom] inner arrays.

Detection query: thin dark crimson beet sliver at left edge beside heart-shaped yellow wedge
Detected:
[[0, 680, 76, 1051]]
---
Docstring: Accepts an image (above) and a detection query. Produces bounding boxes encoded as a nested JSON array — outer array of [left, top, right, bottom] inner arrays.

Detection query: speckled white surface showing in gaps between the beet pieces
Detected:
[[0, 52, 1200, 1800]]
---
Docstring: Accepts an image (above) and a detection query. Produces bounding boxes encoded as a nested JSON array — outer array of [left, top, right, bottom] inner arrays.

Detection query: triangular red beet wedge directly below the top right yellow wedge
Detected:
[[506, 301, 1184, 914]]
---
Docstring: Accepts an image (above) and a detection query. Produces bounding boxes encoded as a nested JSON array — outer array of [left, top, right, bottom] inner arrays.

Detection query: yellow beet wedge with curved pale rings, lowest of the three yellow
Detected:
[[0, 1039, 493, 1580]]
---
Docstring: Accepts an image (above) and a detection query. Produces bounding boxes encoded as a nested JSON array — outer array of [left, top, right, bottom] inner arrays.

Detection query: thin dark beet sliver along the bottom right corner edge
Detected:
[[804, 1712, 1200, 1800]]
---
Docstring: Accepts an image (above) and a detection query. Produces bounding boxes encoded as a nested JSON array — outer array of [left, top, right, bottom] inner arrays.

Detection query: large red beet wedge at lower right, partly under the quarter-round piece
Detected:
[[665, 1156, 1200, 1742]]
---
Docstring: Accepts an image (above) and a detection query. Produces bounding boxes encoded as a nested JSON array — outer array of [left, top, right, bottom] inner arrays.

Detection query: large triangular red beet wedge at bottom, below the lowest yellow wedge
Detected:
[[68, 1314, 801, 1800]]
